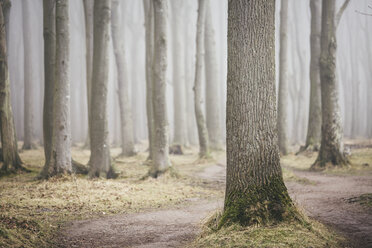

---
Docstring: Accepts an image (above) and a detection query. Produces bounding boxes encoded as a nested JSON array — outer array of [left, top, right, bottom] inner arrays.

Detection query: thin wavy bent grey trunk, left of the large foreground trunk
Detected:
[[194, 0, 209, 157]]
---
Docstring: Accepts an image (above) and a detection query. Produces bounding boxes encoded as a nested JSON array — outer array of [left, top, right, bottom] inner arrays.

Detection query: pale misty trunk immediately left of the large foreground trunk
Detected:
[[204, 0, 223, 149]]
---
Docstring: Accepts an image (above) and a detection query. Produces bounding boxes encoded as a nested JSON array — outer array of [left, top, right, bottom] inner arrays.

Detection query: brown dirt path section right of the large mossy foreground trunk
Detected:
[[286, 170, 372, 247]]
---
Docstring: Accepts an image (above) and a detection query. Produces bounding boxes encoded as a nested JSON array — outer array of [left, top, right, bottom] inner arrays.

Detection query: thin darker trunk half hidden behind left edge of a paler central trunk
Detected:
[[143, 0, 155, 159]]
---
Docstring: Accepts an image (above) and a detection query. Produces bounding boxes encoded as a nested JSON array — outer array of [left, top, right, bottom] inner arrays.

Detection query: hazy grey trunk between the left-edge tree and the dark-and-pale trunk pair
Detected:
[[22, 1, 35, 150]]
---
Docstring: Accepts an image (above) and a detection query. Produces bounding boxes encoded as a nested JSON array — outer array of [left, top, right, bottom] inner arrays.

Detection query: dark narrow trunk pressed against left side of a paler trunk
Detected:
[[43, 0, 56, 169]]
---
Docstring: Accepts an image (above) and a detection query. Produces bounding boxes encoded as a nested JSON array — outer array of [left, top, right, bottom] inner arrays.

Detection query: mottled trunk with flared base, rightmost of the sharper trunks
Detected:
[[312, 0, 348, 169]]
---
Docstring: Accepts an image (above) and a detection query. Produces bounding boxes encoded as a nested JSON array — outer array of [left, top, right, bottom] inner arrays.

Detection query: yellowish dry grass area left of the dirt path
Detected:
[[0, 148, 222, 247]]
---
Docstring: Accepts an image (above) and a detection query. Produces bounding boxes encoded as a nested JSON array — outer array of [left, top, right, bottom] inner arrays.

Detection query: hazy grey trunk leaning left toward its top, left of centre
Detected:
[[111, 0, 136, 156]]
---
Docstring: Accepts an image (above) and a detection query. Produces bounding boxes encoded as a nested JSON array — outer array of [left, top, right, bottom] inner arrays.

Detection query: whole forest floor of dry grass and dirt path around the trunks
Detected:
[[0, 140, 372, 247]]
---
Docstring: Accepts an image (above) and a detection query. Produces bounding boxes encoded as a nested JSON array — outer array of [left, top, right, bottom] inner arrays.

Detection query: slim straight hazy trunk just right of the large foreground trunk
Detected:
[[278, 0, 288, 155]]
